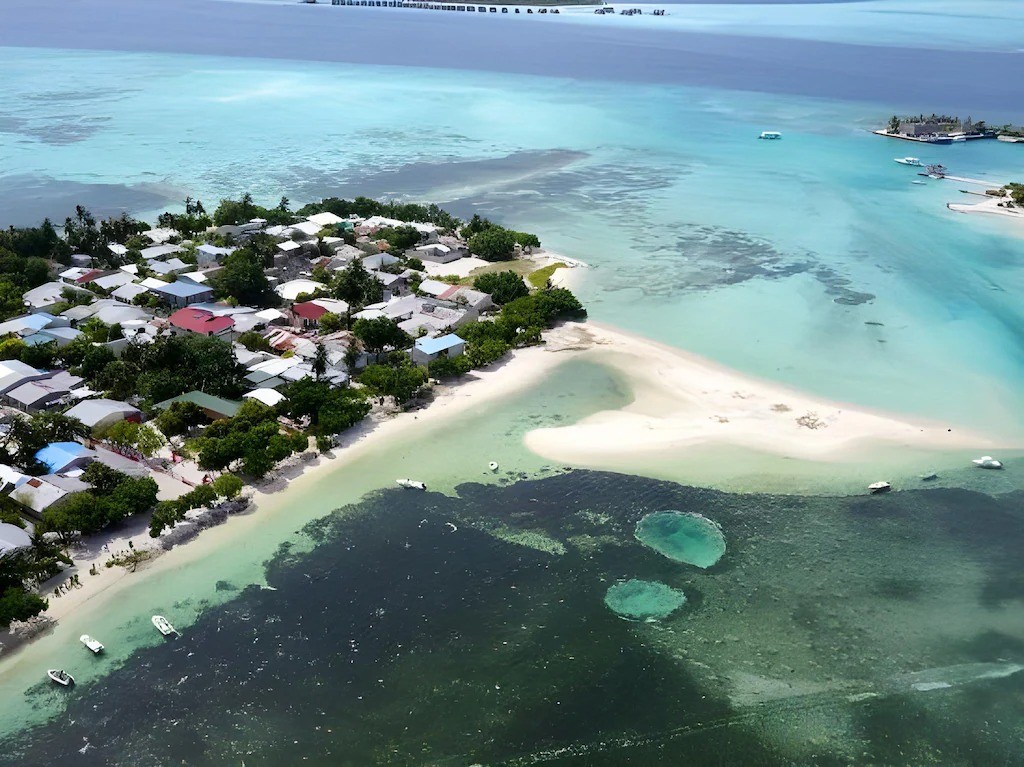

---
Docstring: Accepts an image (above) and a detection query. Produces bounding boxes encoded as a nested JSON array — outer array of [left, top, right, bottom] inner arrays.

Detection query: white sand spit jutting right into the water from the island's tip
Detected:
[[525, 323, 996, 467]]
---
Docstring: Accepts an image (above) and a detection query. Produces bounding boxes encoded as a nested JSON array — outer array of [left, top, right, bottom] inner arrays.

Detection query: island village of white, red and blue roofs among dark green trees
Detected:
[[0, 195, 586, 628]]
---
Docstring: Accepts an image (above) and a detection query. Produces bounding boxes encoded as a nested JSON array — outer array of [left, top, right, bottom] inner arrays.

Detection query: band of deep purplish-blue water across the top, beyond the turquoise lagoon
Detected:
[[0, 0, 1024, 113]]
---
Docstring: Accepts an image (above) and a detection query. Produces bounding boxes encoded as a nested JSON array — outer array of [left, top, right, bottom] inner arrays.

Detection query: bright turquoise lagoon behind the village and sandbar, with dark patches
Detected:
[[0, 41, 1024, 442]]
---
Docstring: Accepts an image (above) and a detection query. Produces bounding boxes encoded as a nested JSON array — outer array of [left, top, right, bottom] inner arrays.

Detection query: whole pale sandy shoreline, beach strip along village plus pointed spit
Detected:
[[0, 317, 1009, 663]]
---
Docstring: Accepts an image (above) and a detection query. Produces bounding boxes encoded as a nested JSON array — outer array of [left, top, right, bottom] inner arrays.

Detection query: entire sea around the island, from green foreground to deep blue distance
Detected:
[[0, 0, 1024, 765]]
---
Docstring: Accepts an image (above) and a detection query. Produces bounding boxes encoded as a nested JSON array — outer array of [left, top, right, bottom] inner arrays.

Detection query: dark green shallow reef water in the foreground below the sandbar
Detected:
[[8, 471, 1024, 767]]
